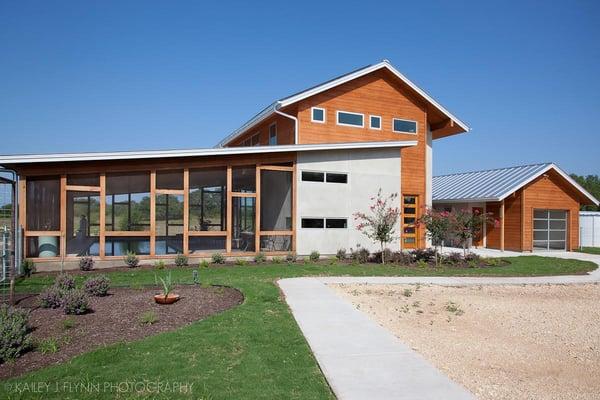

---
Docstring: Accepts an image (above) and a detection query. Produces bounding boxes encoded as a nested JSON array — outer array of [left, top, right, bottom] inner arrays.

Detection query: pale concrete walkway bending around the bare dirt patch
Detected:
[[278, 250, 600, 400]]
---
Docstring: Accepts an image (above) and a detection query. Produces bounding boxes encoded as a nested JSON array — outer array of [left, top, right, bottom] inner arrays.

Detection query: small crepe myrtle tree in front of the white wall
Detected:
[[353, 189, 400, 264]]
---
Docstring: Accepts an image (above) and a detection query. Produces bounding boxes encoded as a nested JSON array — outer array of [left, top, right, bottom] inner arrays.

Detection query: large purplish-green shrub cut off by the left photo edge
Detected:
[[0, 304, 32, 363]]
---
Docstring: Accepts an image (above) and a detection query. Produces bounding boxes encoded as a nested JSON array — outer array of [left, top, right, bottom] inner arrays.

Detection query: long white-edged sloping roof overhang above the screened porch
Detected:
[[0, 140, 417, 166]]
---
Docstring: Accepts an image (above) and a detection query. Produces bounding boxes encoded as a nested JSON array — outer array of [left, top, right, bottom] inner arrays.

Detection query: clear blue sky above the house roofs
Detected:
[[0, 0, 600, 174]]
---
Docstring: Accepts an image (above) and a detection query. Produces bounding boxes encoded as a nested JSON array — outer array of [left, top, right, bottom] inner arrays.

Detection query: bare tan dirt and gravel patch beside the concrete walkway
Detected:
[[331, 284, 600, 400]]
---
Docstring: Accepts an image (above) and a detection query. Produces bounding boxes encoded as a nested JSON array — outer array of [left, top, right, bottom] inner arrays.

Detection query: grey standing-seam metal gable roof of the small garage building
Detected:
[[432, 163, 598, 205]]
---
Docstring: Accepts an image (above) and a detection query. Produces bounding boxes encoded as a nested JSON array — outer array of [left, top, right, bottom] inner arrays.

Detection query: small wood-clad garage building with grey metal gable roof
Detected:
[[433, 163, 598, 251]]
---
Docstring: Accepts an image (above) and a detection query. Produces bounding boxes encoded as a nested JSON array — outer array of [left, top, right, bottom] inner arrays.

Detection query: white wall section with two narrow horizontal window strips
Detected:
[[296, 149, 401, 255]]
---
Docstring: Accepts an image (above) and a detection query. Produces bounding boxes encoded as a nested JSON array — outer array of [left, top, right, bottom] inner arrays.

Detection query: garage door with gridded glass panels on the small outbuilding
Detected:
[[533, 210, 567, 250]]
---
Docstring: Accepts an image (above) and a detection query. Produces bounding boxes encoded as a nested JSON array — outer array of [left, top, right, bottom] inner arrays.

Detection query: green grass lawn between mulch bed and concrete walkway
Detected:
[[0, 256, 596, 399]]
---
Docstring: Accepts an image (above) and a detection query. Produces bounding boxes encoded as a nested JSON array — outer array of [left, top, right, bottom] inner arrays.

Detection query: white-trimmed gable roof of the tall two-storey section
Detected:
[[216, 60, 471, 147]]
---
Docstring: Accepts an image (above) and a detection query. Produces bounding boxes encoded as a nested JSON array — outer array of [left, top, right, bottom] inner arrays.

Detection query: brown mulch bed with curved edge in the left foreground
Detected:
[[0, 286, 244, 379]]
